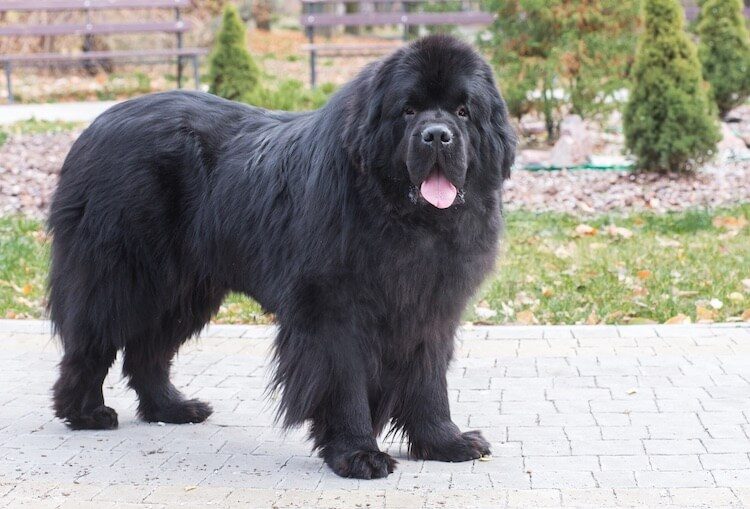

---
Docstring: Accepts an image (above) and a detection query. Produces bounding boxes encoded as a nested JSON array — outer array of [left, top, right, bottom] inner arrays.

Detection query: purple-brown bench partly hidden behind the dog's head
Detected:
[[300, 0, 494, 87]]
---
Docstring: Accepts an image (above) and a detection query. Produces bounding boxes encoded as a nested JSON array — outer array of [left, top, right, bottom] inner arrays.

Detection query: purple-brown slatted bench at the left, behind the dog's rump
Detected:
[[0, 0, 208, 103]]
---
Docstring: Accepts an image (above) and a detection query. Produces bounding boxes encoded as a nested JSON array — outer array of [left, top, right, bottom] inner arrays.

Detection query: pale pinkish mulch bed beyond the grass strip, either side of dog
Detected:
[[0, 132, 750, 218]]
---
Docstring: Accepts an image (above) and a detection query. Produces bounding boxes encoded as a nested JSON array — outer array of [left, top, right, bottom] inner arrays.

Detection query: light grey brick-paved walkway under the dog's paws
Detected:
[[0, 321, 750, 509]]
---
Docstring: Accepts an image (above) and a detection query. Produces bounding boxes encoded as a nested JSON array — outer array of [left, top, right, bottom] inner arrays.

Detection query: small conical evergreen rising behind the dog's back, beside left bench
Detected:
[[208, 4, 260, 101]]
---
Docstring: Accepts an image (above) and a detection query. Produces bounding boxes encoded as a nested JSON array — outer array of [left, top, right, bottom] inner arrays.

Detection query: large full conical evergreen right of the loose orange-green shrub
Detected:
[[623, 0, 719, 173]]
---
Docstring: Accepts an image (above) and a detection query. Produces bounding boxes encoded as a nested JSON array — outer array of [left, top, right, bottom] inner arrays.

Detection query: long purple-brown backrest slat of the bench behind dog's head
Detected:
[[300, 11, 495, 27]]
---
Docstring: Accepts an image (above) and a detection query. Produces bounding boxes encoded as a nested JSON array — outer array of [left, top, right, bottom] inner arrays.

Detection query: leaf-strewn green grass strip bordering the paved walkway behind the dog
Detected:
[[0, 204, 750, 324]]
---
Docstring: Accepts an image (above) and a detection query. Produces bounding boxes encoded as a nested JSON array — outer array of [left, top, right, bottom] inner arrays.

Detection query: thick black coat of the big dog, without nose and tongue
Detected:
[[49, 36, 515, 479]]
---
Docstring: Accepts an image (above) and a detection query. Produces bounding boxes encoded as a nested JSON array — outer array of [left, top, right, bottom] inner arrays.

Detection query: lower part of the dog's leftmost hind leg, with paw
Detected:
[[52, 343, 117, 429]]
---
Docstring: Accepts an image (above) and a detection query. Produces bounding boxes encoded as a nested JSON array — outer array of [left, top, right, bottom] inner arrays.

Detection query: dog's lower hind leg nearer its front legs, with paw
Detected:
[[122, 337, 213, 424]]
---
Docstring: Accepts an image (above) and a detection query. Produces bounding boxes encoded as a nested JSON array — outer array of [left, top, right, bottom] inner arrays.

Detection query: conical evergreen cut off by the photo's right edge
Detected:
[[698, 0, 750, 116]]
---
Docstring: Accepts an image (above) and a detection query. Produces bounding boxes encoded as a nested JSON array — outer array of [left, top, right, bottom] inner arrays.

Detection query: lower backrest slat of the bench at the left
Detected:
[[0, 20, 190, 37]]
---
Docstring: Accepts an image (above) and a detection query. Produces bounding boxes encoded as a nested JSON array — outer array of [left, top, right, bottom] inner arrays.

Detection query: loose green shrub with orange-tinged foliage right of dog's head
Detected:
[[480, 0, 638, 137]]
